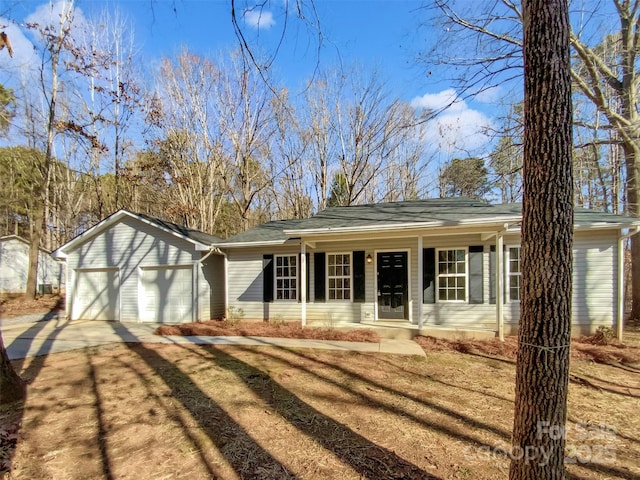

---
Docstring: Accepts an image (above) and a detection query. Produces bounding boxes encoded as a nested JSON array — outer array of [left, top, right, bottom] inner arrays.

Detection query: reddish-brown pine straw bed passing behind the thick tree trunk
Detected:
[[414, 331, 640, 368]]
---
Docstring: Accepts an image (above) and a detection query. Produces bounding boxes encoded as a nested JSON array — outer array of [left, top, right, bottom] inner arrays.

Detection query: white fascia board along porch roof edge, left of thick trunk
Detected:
[[284, 215, 522, 235]]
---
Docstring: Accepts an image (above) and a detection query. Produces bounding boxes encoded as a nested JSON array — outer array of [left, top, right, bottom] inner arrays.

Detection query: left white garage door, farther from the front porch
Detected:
[[71, 269, 120, 320]]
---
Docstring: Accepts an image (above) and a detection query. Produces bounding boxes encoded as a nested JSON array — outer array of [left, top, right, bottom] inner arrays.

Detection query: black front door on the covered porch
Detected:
[[377, 252, 409, 320]]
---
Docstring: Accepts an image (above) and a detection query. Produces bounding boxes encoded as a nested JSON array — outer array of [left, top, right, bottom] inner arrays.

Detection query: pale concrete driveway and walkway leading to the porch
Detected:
[[0, 317, 425, 359]]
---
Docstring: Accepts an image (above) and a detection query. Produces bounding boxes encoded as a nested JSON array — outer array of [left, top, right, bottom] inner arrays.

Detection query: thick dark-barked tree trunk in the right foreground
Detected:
[[509, 0, 573, 480]]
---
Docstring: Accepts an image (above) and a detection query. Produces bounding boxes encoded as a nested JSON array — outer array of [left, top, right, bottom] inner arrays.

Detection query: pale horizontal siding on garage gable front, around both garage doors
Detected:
[[67, 216, 212, 322]]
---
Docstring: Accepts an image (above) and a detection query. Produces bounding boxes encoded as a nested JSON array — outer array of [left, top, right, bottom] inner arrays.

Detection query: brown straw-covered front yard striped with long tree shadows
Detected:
[[0, 338, 640, 480]]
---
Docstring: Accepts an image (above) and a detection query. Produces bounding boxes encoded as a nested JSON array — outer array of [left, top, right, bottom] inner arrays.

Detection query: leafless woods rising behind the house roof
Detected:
[[0, 0, 639, 249]]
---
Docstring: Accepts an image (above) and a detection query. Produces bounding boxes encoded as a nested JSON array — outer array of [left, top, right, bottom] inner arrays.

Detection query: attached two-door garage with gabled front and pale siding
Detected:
[[53, 210, 226, 323]]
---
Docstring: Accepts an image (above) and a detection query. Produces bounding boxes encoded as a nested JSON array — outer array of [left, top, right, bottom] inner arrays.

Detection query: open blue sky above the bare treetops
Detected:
[[0, 0, 510, 157]]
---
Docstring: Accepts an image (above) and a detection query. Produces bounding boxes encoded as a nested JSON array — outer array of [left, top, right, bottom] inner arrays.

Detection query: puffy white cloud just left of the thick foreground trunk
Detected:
[[411, 89, 493, 154]]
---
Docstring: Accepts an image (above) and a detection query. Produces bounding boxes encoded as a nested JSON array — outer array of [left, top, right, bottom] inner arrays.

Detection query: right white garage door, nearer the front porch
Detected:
[[140, 265, 193, 323]]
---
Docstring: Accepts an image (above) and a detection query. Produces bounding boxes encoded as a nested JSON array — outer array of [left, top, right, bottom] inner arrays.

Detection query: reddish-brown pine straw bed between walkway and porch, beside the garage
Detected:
[[156, 320, 380, 343]]
